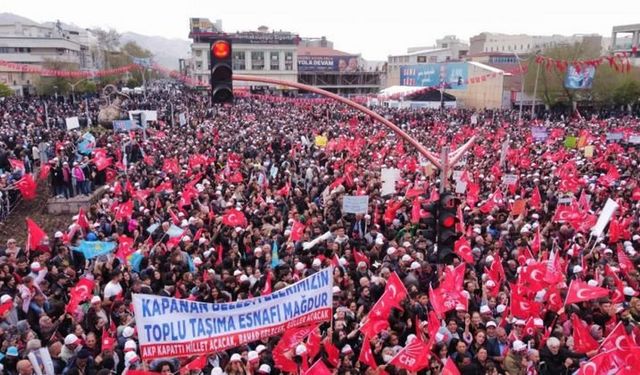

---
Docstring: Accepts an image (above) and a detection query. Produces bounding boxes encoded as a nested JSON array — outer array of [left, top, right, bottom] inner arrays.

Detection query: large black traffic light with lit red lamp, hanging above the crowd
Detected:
[[210, 39, 233, 103]]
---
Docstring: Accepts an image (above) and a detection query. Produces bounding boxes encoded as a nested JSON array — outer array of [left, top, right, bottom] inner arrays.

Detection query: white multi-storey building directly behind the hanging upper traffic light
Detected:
[[186, 18, 299, 90]]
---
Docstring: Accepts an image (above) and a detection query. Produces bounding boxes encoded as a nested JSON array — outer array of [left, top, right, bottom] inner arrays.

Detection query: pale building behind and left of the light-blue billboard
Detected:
[[384, 35, 469, 87]]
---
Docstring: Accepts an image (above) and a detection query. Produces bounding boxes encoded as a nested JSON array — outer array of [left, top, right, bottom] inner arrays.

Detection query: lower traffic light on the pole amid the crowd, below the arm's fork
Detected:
[[437, 191, 460, 264]]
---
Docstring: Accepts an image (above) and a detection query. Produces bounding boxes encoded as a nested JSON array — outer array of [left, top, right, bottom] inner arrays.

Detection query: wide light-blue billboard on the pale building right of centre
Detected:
[[400, 62, 469, 90]]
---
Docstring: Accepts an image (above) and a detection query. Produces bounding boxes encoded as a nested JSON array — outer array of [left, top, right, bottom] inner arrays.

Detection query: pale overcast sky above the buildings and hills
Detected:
[[5, 0, 640, 60]]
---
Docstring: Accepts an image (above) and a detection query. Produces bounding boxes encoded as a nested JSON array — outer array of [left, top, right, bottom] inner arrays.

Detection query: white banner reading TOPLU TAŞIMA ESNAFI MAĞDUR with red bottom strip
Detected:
[[133, 268, 333, 360]]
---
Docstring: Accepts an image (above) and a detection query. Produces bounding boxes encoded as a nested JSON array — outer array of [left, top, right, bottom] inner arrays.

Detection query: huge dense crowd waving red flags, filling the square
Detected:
[[0, 82, 640, 375]]
